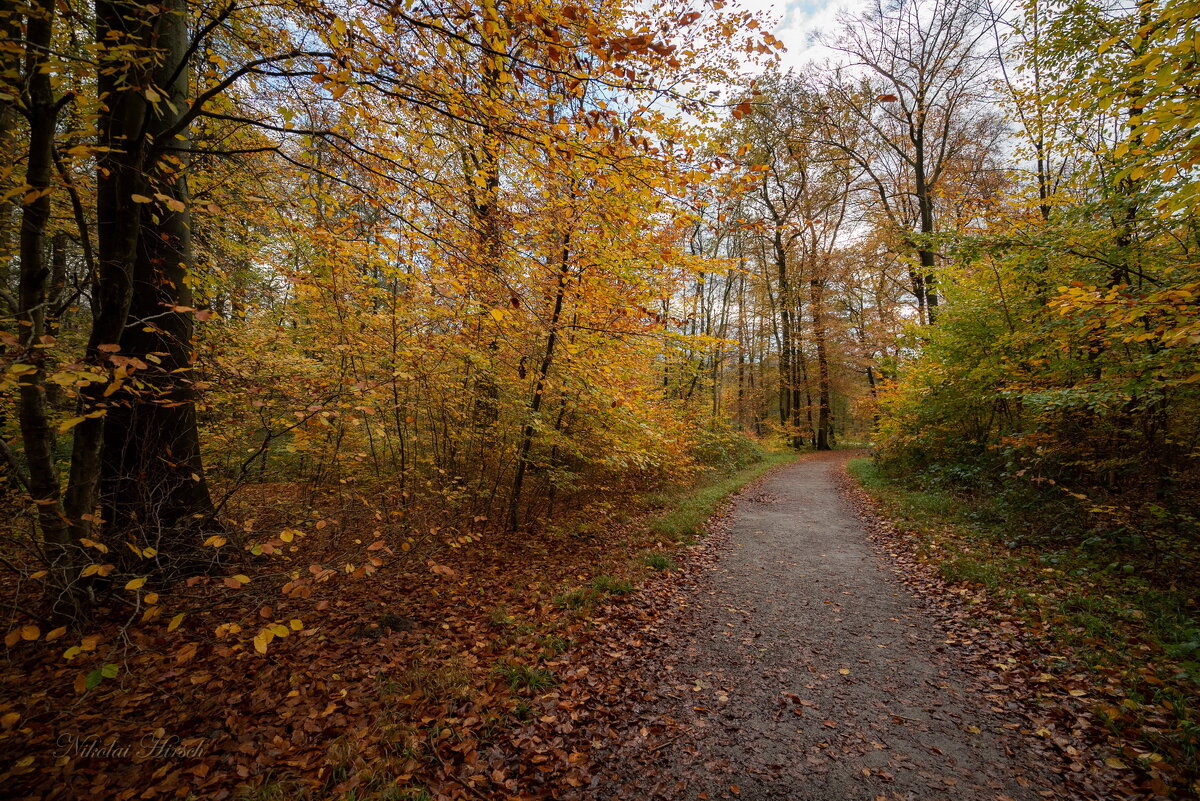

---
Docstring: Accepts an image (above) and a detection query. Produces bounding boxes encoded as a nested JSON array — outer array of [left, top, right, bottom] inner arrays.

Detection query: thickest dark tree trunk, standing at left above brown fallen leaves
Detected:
[[86, 0, 214, 560]]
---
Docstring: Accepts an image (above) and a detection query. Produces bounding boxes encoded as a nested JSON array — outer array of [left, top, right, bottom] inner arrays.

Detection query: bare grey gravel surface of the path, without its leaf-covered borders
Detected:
[[598, 452, 1050, 801]]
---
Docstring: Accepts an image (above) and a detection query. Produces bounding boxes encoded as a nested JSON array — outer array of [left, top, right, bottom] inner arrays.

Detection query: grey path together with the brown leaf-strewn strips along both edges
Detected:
[[499, 452, 1188, 801]]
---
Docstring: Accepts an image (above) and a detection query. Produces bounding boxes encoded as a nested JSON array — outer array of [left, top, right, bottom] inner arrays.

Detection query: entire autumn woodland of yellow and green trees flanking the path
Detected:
[[0, 0, 1200, 797]]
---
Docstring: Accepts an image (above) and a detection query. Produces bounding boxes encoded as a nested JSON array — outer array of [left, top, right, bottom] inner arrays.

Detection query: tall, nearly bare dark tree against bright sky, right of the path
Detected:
[[827, 0, 1002, 321]]
